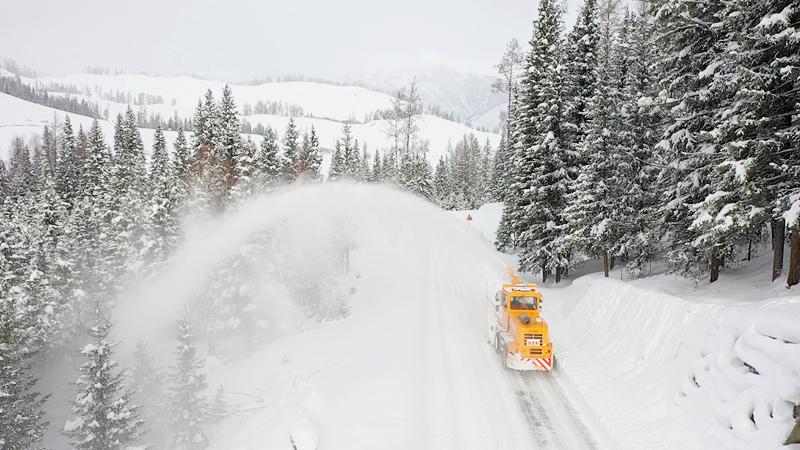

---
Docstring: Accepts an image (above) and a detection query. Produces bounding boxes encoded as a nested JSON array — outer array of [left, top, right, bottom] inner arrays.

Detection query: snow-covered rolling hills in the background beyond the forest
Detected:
[[0, 74, 499, 162]]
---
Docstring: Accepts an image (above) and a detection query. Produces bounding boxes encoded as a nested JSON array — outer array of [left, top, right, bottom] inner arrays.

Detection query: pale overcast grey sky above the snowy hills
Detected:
[[0, 0, 581, 81]]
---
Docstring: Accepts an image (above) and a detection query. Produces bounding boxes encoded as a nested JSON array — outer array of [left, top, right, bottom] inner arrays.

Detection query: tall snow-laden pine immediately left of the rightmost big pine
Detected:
[[655, 0, 735, 281]]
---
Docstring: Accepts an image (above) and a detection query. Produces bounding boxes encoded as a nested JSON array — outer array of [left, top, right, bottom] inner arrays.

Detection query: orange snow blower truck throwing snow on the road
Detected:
[[489, 268, 555, 372]]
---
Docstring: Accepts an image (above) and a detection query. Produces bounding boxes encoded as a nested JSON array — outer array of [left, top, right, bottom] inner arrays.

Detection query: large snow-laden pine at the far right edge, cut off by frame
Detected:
[[709, 0, 800, 279]]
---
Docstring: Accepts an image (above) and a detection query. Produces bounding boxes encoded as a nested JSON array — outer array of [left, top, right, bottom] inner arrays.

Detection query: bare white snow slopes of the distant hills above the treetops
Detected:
[[0, 75, 499, 164]]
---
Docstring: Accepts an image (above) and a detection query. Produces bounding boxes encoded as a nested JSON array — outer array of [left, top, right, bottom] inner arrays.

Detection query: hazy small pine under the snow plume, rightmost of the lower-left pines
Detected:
[[169, 309, 209, 449]]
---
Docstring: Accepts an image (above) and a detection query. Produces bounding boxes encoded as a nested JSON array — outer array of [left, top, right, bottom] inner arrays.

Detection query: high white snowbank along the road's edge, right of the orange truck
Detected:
[[554, 276, 800, 449]]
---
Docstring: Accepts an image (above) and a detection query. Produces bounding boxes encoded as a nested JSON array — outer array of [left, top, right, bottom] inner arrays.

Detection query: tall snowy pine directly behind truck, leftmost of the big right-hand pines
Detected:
[[506, 0, 576, 280]]
